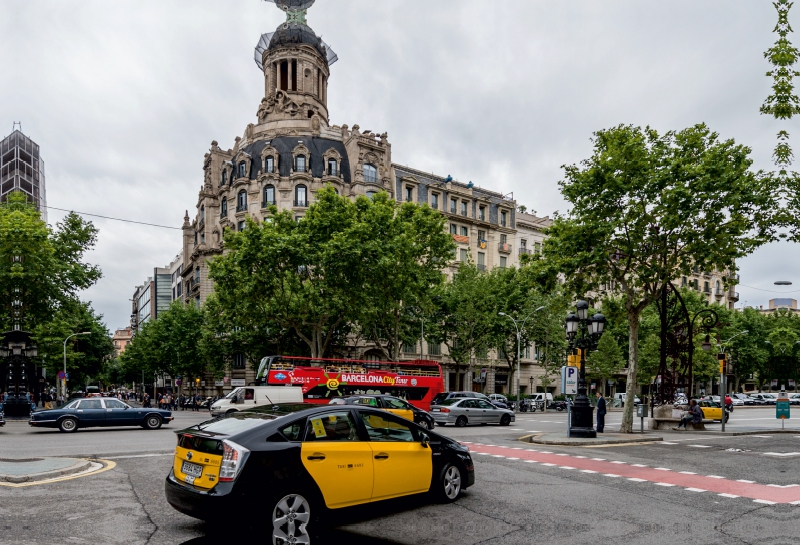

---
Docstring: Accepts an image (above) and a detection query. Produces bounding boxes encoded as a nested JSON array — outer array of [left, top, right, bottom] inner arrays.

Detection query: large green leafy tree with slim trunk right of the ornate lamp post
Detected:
[[545, 125, 778, 433]]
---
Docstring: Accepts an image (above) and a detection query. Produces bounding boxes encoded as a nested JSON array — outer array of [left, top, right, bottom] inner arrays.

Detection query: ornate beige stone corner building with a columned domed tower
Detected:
[[182, 0, 532, 394]]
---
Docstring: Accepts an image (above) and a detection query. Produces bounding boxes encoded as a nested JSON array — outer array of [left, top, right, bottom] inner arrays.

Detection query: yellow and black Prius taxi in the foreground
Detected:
[[165, 404, 475, 544]]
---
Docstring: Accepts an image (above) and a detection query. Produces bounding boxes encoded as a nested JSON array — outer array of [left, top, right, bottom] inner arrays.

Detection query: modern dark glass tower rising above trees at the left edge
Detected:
[[0, 130, 47, 221]]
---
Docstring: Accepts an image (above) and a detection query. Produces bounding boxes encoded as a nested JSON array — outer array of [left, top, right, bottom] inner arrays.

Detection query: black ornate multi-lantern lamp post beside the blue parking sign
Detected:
[[565, 301, 606, 437]]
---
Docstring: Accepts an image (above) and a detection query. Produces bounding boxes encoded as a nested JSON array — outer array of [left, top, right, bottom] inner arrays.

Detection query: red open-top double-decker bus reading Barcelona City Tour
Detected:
[[256, 356, 444, 411]]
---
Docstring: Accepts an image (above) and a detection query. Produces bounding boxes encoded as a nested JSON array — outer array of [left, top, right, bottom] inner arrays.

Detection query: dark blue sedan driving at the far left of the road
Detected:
[[28, 397, 173, 433]]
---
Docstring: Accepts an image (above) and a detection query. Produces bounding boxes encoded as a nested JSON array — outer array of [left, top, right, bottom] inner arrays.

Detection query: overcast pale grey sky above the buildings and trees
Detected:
[[0, 0, 800, 330]]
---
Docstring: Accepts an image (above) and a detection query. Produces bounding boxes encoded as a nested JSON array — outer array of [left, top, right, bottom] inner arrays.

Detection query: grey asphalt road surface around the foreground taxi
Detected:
[[0, 408, 800, 545]]
